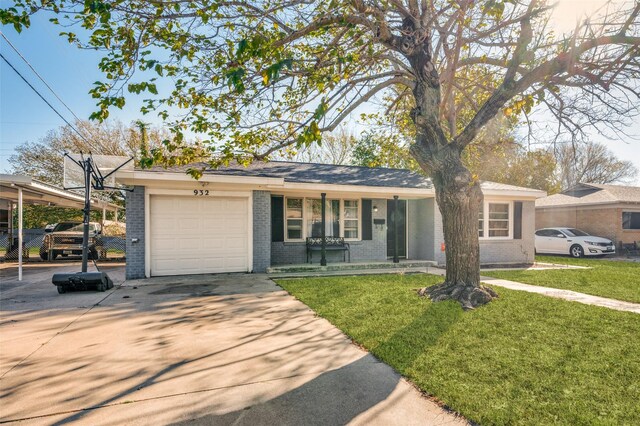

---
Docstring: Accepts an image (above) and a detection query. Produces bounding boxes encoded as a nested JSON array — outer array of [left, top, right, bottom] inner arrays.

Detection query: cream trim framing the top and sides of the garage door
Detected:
[[144, 188, 253, 278]]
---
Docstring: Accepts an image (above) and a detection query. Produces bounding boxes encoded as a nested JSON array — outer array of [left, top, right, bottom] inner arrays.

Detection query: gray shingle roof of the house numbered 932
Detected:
[[145, 161, 433, 189]]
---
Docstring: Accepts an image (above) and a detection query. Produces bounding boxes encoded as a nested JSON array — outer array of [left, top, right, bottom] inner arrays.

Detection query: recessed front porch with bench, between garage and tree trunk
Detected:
[[270, 193, 440, 271]]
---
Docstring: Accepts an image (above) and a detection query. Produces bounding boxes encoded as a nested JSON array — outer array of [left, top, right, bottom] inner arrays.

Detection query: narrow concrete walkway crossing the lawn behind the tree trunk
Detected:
[[427, 268, 640, 314]]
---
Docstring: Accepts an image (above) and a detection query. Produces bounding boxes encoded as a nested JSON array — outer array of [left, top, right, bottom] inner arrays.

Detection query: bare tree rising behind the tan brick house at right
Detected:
[[555, 142, 638, 189]]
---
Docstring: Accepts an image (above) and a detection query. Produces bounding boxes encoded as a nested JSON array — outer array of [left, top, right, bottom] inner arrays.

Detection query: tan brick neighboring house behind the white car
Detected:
[[536, 183, 640, 244]]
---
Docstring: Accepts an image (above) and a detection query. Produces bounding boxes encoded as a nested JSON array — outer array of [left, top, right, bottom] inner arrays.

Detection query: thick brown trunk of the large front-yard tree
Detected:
[[405, 35, 497, 309]]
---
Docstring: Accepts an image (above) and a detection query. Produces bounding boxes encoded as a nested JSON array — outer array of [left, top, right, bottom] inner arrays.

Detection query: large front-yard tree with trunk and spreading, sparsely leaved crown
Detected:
[[6, 0, 640, 308]]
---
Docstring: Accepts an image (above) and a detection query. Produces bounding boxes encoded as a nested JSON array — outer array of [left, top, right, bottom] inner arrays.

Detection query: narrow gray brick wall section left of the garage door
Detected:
[[125, 186, 145, 280]]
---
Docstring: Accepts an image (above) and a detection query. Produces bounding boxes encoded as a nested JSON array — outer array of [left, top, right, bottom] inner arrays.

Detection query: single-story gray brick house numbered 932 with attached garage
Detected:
[[118, 161, 545, 278]]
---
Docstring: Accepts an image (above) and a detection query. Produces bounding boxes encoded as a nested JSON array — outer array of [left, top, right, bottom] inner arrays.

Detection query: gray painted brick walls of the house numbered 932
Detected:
[[126, 186, 536, 279]]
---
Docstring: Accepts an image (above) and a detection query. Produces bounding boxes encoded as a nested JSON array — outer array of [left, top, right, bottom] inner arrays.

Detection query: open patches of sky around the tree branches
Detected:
[[0, 0, 640, 186]]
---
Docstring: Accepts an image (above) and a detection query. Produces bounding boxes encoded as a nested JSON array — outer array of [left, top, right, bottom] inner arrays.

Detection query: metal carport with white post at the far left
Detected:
[[0, 174, 121, 281]]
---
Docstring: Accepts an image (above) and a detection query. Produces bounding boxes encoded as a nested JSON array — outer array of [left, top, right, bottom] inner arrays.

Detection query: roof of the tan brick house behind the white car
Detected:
[[536, 183, 640, 207]]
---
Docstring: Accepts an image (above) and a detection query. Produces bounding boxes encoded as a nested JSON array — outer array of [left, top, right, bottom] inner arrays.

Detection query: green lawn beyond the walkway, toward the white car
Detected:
[[482, 256, 640, 303]]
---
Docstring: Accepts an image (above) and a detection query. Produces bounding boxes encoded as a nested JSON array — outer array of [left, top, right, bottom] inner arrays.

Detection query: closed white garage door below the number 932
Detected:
[[149, 195, 249, 276]]
